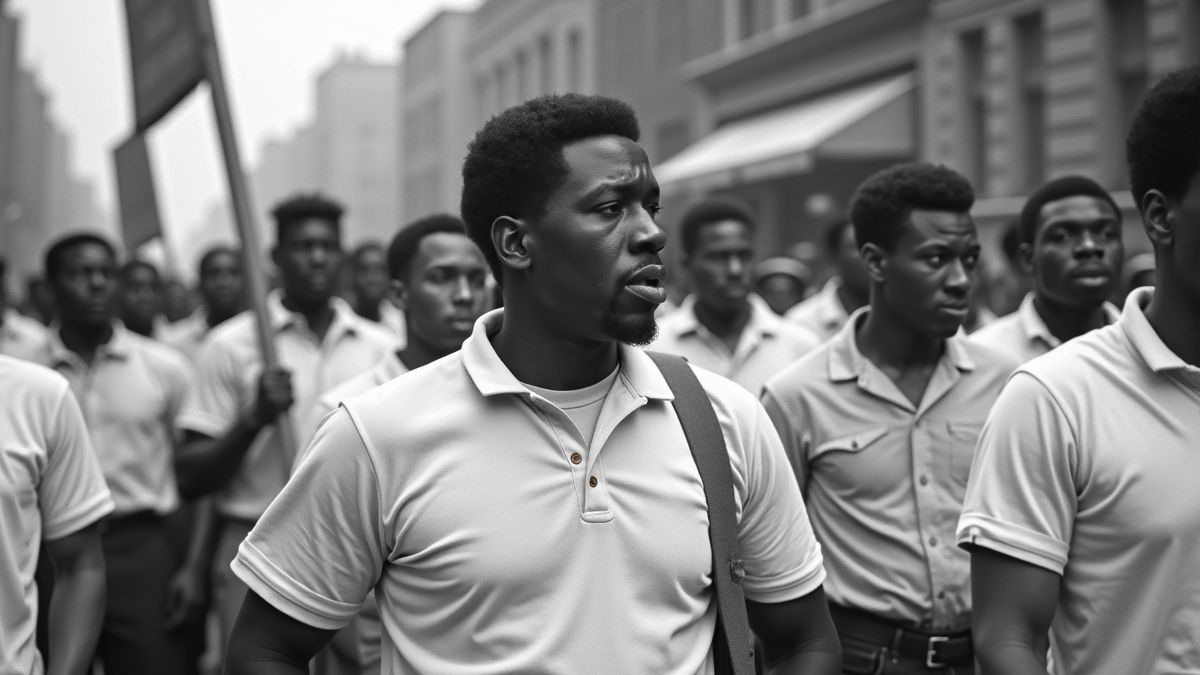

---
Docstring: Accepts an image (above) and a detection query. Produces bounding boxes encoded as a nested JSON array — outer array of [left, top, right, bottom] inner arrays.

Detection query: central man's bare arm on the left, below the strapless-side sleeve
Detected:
[[224, 591, 336, 675]]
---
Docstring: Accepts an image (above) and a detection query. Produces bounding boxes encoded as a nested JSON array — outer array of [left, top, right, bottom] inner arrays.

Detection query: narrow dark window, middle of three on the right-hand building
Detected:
[[1015, 12, 1045, 190]]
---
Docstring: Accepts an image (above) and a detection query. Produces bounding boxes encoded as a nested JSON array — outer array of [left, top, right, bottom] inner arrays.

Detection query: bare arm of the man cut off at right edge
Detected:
[[971, 546, 1061, 675]]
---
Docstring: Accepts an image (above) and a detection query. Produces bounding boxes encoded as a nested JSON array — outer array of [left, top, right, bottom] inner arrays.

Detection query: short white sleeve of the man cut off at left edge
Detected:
[[37, 383, 113, 539]]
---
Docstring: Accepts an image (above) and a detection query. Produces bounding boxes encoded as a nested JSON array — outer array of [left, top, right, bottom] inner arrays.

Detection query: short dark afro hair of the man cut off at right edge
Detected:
[[1126, 66, 1200, 210]]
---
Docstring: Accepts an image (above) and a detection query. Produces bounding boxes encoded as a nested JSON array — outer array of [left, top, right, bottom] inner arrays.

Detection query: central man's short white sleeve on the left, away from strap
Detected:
[[232, 408, 390, 629]]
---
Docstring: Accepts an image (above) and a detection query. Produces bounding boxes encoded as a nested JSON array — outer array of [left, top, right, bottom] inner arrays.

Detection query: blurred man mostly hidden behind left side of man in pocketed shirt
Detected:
[[785, 215, 871, 340]]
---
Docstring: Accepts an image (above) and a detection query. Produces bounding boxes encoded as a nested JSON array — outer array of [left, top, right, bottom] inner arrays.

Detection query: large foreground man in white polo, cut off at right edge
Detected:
[[958, 66, 1200, 675]]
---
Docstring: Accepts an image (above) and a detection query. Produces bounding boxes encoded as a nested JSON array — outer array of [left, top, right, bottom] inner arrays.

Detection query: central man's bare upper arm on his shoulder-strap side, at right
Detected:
[[746, 589, 841, 675]]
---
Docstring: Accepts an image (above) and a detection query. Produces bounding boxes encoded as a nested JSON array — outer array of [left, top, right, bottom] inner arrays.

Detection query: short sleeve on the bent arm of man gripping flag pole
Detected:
[[176, 340, 242, 437]]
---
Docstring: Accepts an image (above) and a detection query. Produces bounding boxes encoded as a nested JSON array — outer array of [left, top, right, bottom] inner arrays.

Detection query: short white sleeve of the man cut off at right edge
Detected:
[[956, 371, 1078, 574]]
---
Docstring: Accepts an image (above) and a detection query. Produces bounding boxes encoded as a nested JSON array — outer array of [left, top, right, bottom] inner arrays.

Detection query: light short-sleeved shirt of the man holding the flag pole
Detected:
[[180, 292, 396, 520]]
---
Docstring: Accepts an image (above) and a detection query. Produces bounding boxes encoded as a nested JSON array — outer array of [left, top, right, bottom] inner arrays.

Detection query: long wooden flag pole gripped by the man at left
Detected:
[[196, 0, 299, 461]]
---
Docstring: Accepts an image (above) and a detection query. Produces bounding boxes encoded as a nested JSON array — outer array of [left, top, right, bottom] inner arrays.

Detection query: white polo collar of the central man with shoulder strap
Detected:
[[462, 307, 674, 401]]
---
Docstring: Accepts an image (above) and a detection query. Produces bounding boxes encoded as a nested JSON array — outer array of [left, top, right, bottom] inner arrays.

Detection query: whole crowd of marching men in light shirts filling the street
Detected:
[[0, 67, 1200, 675]]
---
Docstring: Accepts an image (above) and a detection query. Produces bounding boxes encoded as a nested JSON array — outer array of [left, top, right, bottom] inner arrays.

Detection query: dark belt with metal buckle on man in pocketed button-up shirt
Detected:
[[829, 603, 974, 669]]
